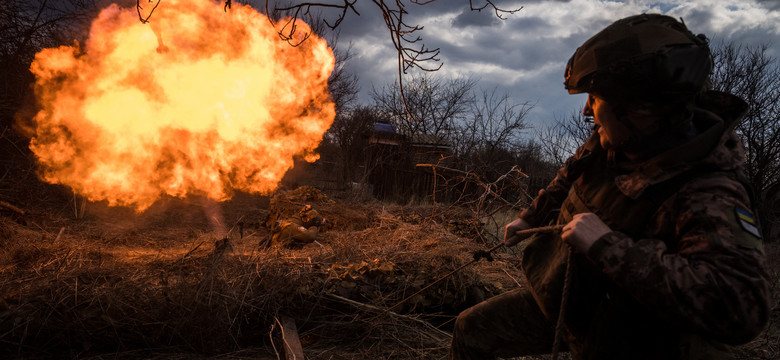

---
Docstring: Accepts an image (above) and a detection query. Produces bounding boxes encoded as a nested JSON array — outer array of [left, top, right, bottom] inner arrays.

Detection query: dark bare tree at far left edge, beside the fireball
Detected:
[[0, 0, 97, 208]]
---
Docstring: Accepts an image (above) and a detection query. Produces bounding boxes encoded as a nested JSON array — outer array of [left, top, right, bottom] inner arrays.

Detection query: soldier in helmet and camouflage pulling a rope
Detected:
[[450, 14, 770, 359]]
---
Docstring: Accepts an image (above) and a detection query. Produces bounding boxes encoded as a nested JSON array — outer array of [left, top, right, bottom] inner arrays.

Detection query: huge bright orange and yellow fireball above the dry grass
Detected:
[[25, 0, 335, 211]]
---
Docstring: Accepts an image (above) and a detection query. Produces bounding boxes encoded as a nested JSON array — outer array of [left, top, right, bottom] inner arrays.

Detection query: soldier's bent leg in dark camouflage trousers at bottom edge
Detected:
[[450, 289, 555, 360]]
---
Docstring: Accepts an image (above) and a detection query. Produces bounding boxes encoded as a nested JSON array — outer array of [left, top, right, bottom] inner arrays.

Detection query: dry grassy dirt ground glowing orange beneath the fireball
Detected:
[[0, 188, 780, 359]]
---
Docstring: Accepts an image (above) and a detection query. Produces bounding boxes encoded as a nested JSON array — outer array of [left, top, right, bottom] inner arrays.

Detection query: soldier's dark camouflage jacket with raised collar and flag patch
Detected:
[[520, 92, 770, 359]]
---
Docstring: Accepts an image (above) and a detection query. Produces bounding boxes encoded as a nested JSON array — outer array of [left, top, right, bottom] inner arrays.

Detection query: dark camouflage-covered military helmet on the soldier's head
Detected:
[[564, 14, 713, 101]]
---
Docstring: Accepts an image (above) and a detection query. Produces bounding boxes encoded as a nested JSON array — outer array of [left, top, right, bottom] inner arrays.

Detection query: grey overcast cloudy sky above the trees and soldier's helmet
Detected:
[[322, 0, 780, 131]]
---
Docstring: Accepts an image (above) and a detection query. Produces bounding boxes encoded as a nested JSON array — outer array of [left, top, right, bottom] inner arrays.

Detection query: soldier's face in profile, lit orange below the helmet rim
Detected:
[[582, 94, 631, 150]]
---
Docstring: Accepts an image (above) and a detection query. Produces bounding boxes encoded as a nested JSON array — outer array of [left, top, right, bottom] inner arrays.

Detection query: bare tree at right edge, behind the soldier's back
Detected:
[[712, 42, 780, 239]]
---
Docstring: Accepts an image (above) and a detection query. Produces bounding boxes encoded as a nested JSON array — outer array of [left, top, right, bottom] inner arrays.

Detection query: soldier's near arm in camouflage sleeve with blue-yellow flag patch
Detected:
[[588, 178, 771, 344]]
